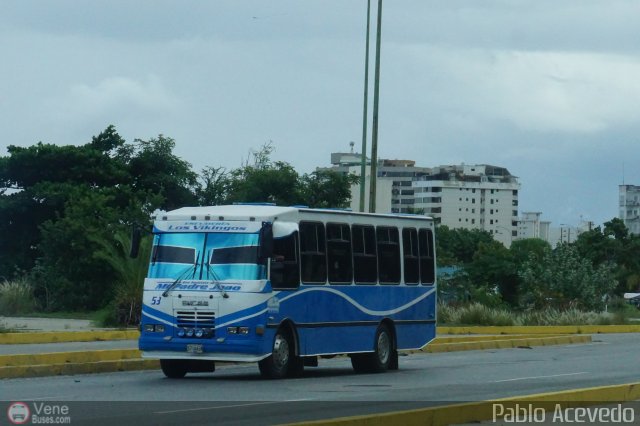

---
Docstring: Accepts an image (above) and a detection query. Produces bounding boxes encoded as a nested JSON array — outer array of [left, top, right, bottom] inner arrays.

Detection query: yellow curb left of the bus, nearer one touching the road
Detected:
[[0, 359, 160, 379]]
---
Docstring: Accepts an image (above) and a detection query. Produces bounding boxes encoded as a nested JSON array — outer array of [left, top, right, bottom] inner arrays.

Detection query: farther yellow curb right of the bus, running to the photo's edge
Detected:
[[437, 325, 640, 334]]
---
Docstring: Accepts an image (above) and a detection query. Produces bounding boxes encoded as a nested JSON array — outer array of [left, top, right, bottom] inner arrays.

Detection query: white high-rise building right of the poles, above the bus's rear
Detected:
[[413, 164, 520, 247]]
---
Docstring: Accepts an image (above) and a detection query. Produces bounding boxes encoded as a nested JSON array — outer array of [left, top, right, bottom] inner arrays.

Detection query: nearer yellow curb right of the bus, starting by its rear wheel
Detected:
[[418, 334, 591, 353]]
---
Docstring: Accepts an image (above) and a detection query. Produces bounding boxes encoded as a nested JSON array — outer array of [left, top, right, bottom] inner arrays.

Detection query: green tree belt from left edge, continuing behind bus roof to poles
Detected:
[[0, 126, 350, 312]]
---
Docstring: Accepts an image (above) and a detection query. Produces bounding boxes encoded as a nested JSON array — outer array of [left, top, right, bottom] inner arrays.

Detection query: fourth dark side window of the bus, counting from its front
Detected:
[[352, 225, 378, 284]]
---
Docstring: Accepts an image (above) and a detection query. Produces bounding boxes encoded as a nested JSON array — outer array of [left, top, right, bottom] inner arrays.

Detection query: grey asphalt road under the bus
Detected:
[[0, 334, 640, 425]]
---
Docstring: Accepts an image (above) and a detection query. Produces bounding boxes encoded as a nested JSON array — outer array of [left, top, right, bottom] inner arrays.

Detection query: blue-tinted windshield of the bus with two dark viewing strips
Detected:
[[148, 232, 266, 281]]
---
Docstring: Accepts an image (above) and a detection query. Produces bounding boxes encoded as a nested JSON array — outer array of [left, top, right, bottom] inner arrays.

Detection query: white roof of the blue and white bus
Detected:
[[156, 203, 432, 222]]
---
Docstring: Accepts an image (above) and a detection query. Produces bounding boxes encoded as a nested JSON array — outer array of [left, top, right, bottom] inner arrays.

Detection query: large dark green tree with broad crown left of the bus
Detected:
[[0, 126, 196, 310]]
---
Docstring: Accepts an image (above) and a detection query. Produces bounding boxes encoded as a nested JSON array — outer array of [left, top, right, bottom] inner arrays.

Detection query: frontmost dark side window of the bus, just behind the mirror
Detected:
[[271, 232, 300, 289]]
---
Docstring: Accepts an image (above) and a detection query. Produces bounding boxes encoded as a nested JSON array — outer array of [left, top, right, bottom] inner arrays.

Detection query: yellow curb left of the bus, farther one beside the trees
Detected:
[[0, 330, 140, 345]]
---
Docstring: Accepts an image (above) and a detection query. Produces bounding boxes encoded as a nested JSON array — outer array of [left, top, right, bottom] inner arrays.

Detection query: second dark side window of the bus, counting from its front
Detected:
[[300, 222, 327, 284]]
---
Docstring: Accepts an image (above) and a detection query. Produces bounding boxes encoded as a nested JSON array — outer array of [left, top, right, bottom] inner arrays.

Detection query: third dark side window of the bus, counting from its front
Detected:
[[327, 223, 353, 284]]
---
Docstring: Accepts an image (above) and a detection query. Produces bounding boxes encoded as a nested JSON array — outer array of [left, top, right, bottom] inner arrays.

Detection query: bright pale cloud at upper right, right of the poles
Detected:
[[394, 45, 640, 134]]
